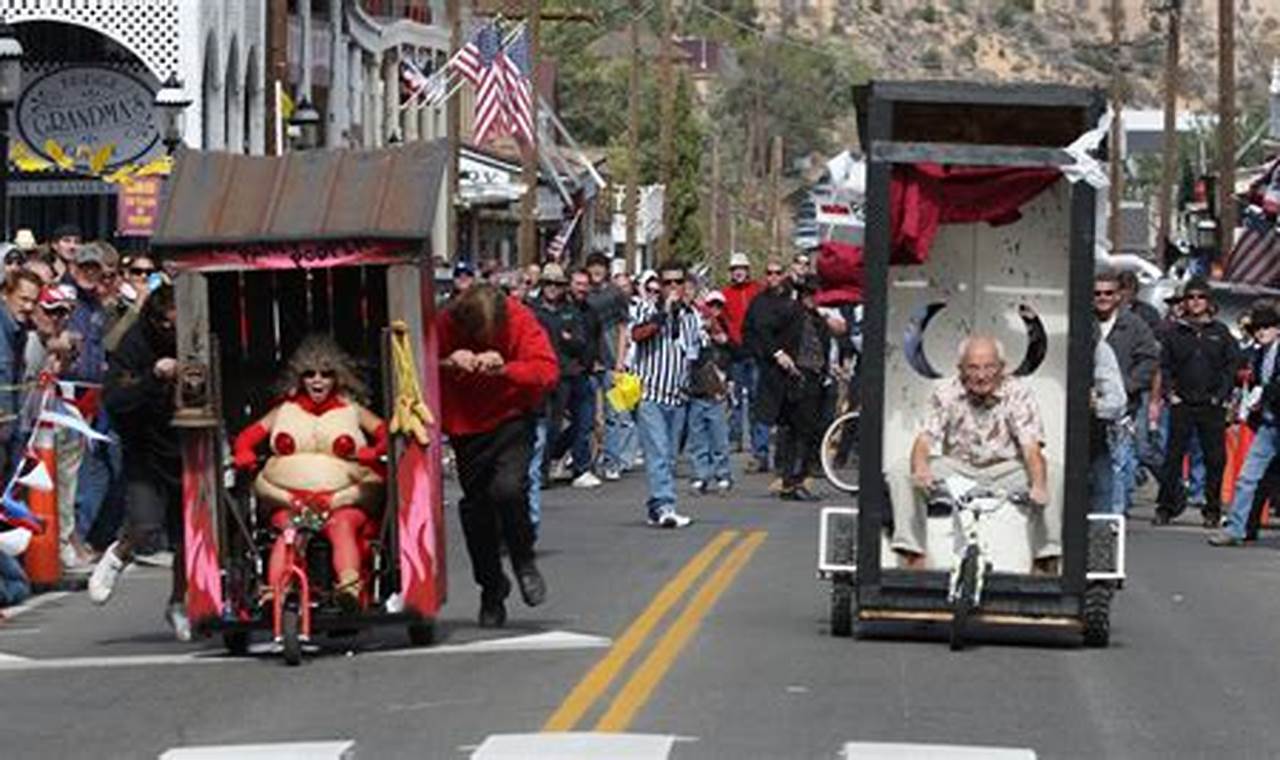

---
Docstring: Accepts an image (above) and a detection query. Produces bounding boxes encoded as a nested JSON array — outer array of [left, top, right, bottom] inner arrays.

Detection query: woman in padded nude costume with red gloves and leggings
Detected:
[[236, 335, 387, 609]]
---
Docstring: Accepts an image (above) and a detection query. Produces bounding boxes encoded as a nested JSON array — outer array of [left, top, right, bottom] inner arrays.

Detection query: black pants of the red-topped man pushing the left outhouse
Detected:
[[451, 417, 534, 595]]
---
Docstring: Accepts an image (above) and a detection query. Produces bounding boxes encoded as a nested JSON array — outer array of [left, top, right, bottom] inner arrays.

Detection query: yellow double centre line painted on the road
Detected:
[[543, 531, 768, 732]]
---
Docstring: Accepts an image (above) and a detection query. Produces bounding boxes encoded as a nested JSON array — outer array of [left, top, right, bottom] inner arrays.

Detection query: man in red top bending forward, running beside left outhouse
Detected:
[[436, 283, 559, 628]]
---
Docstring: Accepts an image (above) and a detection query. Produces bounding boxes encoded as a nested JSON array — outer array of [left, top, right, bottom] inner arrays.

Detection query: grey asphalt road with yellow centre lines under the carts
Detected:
[[0, 458, 1280, 759]]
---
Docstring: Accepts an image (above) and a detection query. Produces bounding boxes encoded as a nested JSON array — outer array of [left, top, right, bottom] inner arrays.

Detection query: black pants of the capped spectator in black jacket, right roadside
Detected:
[[1157, 403, 1226, 519]]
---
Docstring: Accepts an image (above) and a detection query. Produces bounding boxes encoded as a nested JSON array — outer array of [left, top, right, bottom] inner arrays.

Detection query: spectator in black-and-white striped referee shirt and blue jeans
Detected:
[[631, 262, 704, 528]]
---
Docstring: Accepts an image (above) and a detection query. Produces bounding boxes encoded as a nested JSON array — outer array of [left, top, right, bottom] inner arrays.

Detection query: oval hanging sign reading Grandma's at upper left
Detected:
[[15, 67, 160, 174]]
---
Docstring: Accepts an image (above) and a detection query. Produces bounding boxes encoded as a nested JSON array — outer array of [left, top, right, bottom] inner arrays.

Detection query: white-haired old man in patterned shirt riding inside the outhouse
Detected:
[[891, 335, 1056, 572]]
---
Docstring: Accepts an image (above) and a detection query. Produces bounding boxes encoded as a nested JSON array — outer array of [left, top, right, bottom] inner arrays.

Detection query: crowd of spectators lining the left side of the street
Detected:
[[0, 225, 183, 623]]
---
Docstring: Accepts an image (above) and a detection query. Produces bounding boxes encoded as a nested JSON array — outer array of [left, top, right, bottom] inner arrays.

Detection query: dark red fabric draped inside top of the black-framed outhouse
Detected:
[[890, 164, 1061, 265]]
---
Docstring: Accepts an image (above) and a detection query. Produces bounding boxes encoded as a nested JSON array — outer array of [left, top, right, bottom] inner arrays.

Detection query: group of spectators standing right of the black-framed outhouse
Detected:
[[1091, 270, 1280, 546]]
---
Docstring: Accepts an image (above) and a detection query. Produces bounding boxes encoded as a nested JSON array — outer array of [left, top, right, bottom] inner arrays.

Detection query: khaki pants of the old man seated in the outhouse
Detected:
[[890, 457, 1062, 559]]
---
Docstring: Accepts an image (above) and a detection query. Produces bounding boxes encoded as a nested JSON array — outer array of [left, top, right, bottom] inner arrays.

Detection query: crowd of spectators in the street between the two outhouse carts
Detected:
[[452, 245, 858, 536]]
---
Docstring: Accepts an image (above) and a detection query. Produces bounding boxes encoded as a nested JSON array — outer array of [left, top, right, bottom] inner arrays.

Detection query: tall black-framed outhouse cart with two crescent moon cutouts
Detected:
[[818, 82, 1125, 649]]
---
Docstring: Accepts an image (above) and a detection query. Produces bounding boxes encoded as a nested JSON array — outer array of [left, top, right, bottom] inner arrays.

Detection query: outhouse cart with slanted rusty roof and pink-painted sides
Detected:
[[152, 141, 447, 664]]
